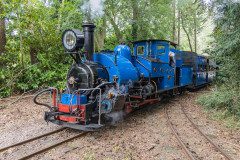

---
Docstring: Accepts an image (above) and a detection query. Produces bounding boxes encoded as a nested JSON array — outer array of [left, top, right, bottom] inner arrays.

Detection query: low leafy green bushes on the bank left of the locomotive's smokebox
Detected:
[[0, 52, 71, 97]]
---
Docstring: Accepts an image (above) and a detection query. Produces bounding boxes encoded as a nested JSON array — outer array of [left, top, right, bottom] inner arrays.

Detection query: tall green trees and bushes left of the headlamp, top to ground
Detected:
[[0, 0, 82, 97]]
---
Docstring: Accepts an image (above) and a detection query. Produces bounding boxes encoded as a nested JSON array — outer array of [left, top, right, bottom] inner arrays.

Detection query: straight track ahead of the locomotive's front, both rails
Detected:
[[0, 128, 88, 160]]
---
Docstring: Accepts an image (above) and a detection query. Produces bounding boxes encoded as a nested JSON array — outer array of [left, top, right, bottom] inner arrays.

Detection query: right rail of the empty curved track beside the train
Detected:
[[180, 104, 232, 160]]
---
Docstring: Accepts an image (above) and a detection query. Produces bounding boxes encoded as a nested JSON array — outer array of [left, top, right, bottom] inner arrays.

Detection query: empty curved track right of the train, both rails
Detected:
[[165, 104, 232, 160]]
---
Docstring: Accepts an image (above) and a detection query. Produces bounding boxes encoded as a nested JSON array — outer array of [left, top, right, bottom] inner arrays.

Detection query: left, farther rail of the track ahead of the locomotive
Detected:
[[0, 127, 66, 152]]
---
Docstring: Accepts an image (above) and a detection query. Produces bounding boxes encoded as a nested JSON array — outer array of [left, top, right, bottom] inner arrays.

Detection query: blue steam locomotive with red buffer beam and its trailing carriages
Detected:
[[34, 23, 216, 130]]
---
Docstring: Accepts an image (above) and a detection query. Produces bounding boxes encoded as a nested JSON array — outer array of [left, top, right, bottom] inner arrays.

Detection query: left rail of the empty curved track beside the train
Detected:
[[165, 107, 195, 160]]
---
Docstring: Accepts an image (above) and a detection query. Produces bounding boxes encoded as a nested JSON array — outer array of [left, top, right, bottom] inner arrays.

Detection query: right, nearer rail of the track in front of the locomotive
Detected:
[[19, 132, 88, 160]]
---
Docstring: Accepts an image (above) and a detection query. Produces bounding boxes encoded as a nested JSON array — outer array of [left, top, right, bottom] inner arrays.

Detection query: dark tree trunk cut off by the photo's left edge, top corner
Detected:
[[0, 2, 6, 55]]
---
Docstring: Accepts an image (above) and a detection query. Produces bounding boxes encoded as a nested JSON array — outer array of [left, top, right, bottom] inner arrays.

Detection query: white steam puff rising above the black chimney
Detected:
[[81, 0, 105, 20]]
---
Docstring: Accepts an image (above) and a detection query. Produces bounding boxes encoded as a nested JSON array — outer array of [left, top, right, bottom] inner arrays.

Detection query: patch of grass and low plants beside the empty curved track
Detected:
[[197, 88, 240, 129]]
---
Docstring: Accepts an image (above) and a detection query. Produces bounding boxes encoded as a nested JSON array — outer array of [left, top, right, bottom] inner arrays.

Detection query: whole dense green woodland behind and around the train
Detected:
[[0, 0, 240, 119]]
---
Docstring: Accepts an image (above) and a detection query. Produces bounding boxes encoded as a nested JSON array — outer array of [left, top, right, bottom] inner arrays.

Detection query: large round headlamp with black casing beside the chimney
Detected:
[[62, 29, 84, 52]]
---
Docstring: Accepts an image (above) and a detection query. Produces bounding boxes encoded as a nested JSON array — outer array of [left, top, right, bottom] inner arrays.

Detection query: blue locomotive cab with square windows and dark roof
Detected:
[[133, 40, 177, 90]]
